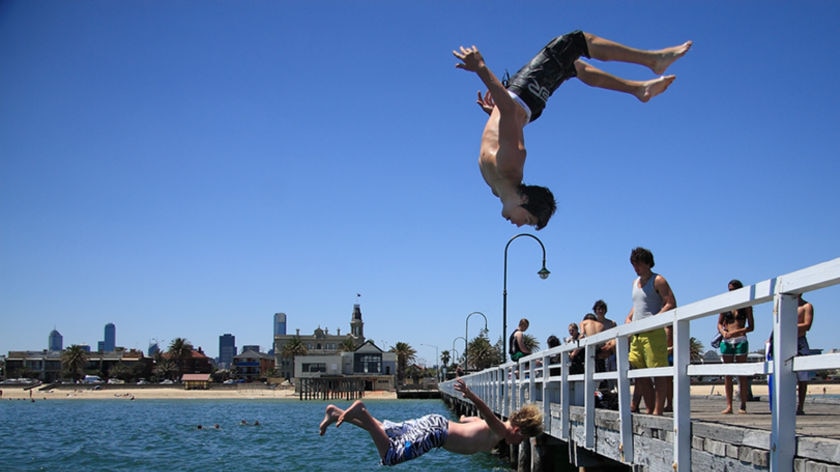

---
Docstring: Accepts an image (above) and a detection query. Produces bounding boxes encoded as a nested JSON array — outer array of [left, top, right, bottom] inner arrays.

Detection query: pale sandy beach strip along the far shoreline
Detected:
[[6, 382, 840, 400]]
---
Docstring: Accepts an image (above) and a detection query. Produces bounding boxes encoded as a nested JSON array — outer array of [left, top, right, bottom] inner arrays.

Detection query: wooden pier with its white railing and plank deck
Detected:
[[440, 258, 840, 472]]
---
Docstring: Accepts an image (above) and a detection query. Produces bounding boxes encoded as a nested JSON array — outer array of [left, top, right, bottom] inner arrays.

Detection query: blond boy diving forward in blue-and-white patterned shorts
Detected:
[[320, 378, 543, 465]]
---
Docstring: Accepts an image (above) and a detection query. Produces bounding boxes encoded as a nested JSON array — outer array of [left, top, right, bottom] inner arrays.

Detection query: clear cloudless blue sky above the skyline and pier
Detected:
[[0, 0, 840, 363]]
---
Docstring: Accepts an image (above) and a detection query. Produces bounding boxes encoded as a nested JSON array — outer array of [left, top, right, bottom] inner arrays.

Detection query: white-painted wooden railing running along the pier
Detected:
[[440, 258, 840, 471]]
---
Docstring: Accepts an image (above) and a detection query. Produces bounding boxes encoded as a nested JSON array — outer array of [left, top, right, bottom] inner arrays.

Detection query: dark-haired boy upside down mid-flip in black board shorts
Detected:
[[452, 31, 692, 230]]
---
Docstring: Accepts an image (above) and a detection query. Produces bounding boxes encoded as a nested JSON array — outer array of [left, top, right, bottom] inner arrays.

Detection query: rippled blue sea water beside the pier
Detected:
[[0, 399, 509, 472]]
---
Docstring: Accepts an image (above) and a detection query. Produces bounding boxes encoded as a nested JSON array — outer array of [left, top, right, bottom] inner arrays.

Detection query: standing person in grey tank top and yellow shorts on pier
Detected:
[[625, 247, 677, 416]]
